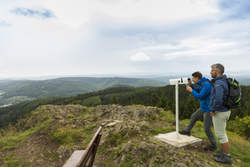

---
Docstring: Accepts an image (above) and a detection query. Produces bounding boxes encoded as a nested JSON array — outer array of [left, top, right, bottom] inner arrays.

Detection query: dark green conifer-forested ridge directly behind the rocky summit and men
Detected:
[[0, 85, 250, 128]]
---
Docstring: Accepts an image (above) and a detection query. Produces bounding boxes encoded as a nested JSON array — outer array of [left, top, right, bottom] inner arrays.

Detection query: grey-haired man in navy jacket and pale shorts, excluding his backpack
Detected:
[[210, 63, 232, 164]]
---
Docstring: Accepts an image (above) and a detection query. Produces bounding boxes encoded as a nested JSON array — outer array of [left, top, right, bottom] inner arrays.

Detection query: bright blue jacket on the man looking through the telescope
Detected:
[[191, 77, 212, 112]]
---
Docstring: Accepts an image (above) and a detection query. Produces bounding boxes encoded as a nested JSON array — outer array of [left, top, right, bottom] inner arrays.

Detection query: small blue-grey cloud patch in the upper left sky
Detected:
[[10, 7, 55, 19]]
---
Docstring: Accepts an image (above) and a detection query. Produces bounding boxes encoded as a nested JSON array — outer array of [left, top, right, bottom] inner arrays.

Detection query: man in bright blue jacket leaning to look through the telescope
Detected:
[[179, 71, 217, 151]]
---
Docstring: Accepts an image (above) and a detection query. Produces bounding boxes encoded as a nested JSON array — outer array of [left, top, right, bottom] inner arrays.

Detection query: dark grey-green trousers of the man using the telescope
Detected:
[[185, 108, 217, 147]]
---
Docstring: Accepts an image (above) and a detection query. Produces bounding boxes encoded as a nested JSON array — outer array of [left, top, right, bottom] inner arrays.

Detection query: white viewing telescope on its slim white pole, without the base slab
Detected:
[[169, 78, 191, 139]]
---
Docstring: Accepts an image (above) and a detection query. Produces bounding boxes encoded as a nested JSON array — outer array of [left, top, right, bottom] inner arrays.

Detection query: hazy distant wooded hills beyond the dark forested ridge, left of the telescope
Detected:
[[0, 77, 166, 105]]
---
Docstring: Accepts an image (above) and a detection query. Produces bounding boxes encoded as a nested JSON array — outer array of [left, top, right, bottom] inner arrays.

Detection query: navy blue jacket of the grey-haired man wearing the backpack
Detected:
[[210, 75, 230, 112]]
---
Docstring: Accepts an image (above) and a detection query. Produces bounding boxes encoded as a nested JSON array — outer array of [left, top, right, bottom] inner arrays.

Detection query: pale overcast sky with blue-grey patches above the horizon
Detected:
[[0, 0, 250, 78]]
